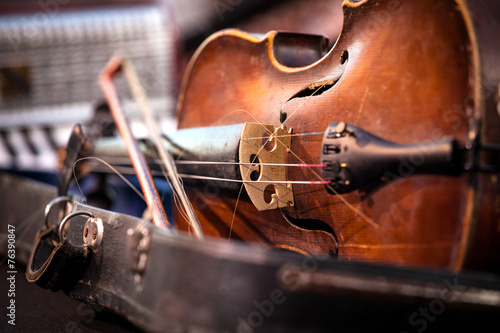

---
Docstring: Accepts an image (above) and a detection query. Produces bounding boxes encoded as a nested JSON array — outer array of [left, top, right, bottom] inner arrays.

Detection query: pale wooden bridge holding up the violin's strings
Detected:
[[239, 123, 294, 211]]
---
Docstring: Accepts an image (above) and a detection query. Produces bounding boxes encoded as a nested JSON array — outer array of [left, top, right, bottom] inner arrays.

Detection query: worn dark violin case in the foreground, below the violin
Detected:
[[0, 173, 500, 332]]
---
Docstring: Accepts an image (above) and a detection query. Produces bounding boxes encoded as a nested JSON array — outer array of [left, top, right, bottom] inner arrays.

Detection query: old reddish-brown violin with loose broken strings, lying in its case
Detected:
[[94, 0, 500, 271]]
